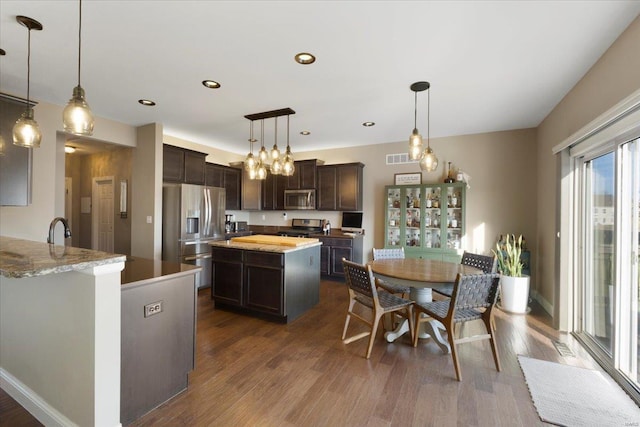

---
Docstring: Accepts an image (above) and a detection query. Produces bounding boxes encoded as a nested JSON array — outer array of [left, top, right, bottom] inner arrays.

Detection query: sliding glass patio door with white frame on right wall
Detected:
[[577, 139, 640, 390]]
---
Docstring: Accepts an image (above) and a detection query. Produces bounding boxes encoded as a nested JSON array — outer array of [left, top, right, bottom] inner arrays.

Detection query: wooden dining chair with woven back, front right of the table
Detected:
[[413, 273, 500, 381]]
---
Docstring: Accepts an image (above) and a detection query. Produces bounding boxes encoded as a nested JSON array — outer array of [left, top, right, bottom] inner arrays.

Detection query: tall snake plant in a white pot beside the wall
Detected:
[[492, 234, 529, 314]]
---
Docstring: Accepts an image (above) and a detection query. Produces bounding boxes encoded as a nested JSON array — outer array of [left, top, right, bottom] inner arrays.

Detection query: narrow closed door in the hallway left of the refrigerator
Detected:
[[91, 177, 114, 252]]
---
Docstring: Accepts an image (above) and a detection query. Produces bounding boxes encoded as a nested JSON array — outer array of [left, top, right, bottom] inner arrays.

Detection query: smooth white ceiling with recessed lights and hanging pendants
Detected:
[[0, 0, 640, 154]]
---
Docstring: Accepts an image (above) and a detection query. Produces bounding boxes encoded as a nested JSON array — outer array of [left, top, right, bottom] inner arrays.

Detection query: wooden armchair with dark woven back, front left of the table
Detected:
[[342, 258, 414, 359]]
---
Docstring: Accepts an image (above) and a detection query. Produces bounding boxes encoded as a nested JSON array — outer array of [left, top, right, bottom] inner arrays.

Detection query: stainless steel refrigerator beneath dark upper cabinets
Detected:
[[162, 183, 225, 288]]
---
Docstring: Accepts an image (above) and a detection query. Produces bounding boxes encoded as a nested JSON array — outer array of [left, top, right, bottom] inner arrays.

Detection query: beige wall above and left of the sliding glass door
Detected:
[[534, 17, 640, 330]]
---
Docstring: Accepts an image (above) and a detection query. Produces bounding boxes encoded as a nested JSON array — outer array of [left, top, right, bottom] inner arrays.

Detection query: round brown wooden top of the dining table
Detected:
[[369, 258, 482, 285]]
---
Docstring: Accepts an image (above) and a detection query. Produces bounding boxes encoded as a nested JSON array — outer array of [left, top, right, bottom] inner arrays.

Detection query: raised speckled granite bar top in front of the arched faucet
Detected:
[[0, 236, 126, 278]]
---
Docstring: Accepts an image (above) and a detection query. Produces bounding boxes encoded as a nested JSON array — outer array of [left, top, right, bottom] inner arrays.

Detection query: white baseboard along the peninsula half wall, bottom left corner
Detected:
[[0, 368, 77, 427]]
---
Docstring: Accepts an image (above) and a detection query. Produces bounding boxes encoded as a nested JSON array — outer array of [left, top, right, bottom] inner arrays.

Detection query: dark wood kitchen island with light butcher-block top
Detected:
[[210, 235, 322, 323]]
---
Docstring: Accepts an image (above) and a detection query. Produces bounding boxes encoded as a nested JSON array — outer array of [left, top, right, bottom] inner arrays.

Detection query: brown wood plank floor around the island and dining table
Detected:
[[0, 281, 597, 426]]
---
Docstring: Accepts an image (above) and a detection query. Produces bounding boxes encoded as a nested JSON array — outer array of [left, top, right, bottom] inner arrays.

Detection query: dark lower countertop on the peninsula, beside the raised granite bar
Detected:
[[120, 257, 202, 285]]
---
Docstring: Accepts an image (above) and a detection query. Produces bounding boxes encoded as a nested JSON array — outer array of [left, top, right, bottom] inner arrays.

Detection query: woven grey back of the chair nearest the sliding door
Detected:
[[452, 273, 500, 311]]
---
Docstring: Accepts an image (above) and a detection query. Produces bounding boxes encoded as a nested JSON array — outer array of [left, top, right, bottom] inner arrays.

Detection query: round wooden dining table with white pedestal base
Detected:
[[368, 258, 482, 353]]
